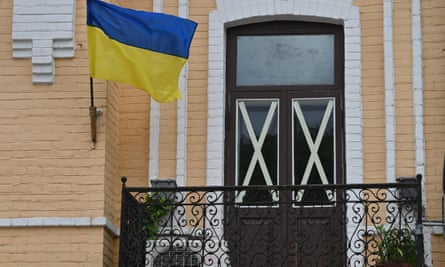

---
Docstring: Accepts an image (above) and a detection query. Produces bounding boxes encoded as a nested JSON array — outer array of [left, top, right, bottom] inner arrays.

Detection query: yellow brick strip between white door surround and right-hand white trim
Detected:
[[355, 0, 386, 183]]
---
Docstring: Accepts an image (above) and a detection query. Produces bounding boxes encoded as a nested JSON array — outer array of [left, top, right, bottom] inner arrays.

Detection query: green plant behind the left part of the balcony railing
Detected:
[[142, 193, 173, 240]]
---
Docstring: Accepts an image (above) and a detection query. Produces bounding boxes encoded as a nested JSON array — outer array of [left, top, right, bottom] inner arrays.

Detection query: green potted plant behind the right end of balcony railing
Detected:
[[376, 225, 417, 267]]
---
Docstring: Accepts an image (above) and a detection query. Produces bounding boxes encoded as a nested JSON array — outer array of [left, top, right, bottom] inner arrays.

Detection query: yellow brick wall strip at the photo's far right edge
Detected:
[[422, 0, 445, 222]]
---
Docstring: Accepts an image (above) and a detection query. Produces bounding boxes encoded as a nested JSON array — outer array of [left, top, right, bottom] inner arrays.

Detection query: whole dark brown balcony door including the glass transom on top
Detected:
[[224, 20, 346, 267]]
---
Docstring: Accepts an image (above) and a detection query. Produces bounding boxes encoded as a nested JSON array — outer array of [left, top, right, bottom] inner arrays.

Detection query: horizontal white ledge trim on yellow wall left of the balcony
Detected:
[[0, 217, 120, 237]]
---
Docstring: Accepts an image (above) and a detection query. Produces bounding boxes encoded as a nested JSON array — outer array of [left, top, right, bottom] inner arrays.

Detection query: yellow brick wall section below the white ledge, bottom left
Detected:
[[0, 227, 103, 267]]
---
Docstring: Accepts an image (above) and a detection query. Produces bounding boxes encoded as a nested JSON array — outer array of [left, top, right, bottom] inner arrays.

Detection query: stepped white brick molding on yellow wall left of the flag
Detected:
[[12, 0, 75, 83]]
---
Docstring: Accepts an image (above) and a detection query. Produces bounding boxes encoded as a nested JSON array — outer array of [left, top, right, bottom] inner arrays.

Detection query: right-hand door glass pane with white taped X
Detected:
[[293, 99, 335, 201]]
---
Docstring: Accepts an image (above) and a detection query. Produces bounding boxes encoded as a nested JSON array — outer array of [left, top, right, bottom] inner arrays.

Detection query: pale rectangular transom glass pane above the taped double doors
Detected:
[[236, 34, 334, 86]]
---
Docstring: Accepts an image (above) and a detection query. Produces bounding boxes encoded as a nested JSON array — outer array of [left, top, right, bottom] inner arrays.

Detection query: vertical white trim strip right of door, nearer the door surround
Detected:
[[383, 0, 396, 183]]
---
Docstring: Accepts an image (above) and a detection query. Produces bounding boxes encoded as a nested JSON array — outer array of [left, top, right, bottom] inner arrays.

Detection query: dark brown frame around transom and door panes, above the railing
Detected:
[[225, 20, 346, 188]]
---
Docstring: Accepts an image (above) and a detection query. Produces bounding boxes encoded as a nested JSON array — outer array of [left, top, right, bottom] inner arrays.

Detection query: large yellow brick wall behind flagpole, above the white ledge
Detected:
[[0, 1, 105, 218]]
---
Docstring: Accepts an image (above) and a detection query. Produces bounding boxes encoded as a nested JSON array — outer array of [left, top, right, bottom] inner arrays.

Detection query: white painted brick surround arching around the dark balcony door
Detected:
[[207, 0, 363, 186]]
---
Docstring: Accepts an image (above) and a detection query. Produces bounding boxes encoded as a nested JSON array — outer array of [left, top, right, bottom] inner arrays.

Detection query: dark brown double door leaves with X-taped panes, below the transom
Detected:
[[225, 91, 345, 266]]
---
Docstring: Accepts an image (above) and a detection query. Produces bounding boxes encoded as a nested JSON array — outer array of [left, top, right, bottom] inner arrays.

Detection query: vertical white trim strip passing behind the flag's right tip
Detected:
[[176, 0, 189, 186]]
